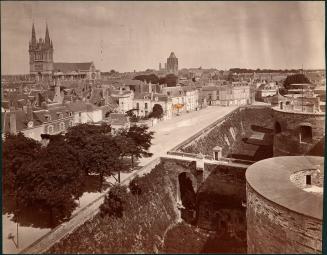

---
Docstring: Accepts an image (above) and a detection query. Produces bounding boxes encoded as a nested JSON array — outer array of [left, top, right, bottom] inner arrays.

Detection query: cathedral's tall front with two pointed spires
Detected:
[[29, 24, 53, 79]]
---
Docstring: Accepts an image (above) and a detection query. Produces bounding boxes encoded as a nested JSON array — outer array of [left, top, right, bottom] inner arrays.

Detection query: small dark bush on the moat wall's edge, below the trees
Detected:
[[100, 185, 130, 218]]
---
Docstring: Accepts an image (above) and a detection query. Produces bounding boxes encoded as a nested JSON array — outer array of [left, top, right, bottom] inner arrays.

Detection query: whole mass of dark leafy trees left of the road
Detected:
[[2, 124, 153, 225]]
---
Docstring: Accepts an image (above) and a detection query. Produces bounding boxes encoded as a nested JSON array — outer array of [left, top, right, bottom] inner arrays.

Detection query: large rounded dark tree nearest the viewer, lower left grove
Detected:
[[16, 136, 82, 225]]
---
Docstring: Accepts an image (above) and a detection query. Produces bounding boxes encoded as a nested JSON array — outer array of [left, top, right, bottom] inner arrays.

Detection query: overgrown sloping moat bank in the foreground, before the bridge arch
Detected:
[[46, 164, 177, 254]]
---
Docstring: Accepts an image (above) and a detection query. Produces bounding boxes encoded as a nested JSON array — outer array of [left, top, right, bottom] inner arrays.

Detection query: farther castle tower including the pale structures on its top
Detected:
[[272, 92, 325, 157]]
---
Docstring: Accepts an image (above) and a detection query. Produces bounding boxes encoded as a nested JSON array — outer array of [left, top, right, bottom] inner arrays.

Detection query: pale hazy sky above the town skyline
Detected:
[[1, 1, 325, 74]]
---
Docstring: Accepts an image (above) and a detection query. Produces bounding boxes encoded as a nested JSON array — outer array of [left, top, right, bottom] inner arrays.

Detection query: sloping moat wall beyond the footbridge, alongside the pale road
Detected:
[[179, 107, 273, 157]]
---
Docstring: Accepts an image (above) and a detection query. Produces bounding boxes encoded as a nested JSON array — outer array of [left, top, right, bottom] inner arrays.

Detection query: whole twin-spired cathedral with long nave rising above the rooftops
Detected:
[[29, 24, 100, 80]]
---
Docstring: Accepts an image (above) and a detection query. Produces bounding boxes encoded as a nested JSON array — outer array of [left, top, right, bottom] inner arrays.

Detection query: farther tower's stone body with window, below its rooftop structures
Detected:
[[273, 108, 325, 157]]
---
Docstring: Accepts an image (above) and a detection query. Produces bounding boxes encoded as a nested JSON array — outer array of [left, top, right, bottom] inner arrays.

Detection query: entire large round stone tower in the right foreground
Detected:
[[246, 156, 324, 254]]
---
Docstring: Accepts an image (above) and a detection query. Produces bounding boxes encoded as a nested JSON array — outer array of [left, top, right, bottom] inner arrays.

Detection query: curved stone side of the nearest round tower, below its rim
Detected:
[[246, 184, 322, 254]]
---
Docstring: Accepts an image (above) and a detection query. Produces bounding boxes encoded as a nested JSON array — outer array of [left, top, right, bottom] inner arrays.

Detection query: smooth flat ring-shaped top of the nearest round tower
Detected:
[[245, 156, 324, 220]]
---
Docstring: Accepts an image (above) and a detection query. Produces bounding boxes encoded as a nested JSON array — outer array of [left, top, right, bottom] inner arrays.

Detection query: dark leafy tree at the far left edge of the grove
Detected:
[[2, 133, 41, 194]]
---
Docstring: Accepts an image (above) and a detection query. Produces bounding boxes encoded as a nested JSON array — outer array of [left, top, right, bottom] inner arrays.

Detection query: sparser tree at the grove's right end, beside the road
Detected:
[[121, 125, 154, 167]]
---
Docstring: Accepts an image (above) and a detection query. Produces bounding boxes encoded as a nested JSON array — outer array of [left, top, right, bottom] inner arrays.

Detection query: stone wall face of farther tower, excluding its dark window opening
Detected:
[[273, 109, 325, 157]]
